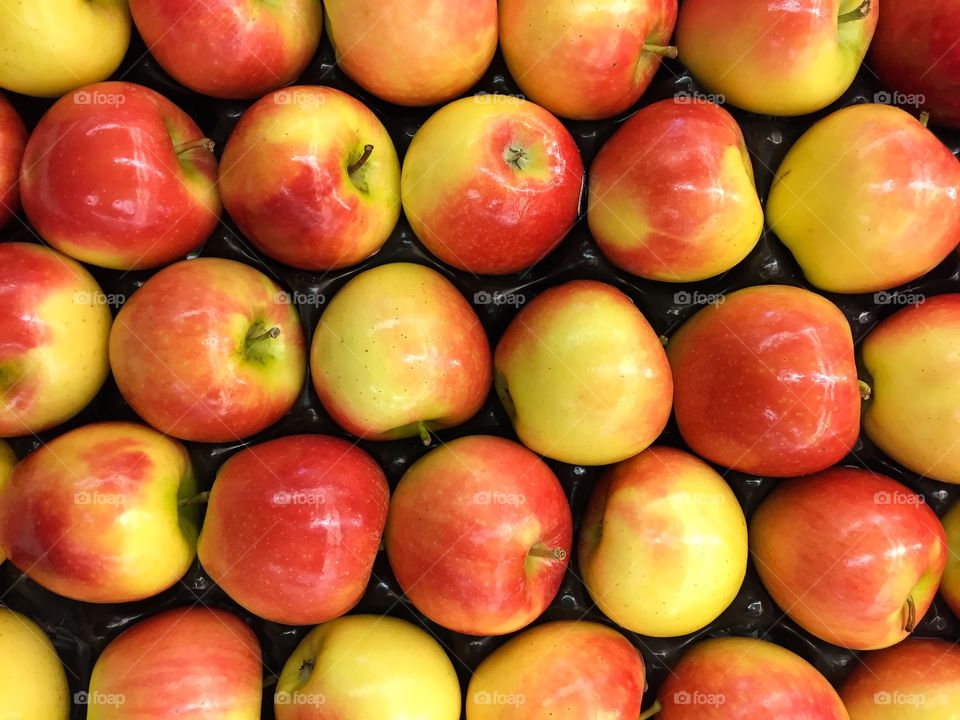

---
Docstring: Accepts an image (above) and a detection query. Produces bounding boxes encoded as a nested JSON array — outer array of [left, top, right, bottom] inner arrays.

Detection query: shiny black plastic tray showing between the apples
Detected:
[[0, 11, 960, 720]]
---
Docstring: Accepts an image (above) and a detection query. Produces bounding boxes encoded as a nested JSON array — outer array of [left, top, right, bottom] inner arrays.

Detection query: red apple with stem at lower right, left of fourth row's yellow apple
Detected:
[[385, 435, 573, 635]]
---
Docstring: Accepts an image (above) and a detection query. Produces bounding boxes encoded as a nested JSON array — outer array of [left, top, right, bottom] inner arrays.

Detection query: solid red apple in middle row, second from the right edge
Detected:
[[667, 285, 860, 477]]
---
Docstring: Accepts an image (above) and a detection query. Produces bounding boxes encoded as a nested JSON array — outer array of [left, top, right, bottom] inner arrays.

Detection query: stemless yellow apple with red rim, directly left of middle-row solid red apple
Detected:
[[494, 280, 673, 465]]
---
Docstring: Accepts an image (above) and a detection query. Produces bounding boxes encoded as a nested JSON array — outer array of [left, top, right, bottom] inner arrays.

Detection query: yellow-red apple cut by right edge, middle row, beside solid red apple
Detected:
[[862, 294, 960, 483]]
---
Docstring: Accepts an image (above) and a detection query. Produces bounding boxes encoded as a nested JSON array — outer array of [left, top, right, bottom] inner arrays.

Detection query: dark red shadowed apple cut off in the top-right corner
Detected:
[[870, 0, 960, 127]]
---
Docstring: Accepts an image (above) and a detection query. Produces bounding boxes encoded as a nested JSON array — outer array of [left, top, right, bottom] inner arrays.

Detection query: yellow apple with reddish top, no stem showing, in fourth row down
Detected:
[[578, 447, 748, 637]]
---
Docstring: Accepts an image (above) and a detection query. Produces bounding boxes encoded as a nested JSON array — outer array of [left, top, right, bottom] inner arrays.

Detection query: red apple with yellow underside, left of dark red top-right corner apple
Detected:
[[676, 0, 880, 116]]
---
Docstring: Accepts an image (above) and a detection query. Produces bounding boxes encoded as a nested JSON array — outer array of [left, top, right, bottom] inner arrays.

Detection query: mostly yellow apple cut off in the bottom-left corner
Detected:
[[0, 607, 70, 720]]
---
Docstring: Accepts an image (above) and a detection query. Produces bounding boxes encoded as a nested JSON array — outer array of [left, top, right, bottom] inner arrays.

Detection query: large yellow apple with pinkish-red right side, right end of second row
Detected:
[[766, 104, 960, 293]]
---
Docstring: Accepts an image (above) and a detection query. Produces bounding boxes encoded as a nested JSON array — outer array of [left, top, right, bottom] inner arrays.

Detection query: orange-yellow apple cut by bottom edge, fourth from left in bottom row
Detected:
[[467, 621, 645, 720]]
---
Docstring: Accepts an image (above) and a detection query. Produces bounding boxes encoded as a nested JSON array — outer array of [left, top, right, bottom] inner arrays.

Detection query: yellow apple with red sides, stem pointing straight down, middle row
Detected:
[[310, 263, 492, 444]]
